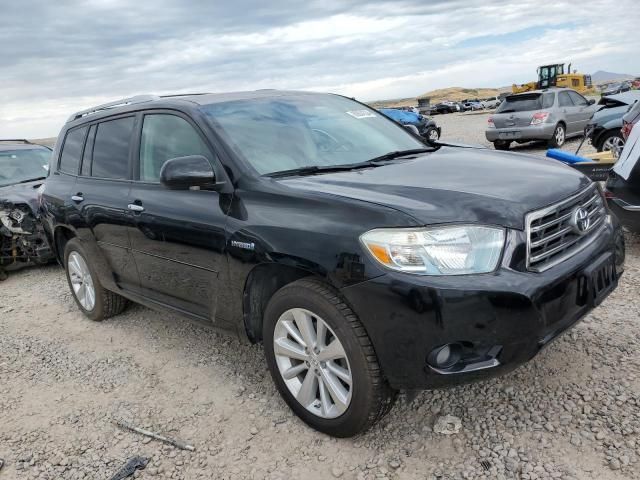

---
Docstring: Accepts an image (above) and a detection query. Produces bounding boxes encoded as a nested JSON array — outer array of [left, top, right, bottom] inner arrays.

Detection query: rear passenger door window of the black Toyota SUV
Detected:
[[91, 117, 134, 179]]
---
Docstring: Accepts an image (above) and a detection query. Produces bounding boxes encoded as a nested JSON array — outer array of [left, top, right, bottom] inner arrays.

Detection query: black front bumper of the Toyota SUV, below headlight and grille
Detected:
[[342, 217, 624, 389]]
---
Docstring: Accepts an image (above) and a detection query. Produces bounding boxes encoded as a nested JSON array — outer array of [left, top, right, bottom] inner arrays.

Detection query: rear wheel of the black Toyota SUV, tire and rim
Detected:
[[64, 238, 128, 322]]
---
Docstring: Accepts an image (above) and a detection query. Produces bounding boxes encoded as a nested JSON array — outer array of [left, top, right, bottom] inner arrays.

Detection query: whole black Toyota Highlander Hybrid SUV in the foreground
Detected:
[[43, 90, 624, 436]]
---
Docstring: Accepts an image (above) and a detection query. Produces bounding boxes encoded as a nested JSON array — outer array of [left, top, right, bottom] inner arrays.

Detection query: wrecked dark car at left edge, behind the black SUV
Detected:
[[0, 140, 54, 280]]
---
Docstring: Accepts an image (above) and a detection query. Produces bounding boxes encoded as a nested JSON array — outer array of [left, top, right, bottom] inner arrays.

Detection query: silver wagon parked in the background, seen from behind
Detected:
[[485, 88, 597, 150]]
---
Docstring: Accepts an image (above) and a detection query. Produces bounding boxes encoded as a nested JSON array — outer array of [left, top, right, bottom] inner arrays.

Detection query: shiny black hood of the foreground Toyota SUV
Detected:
[[278, 147, 591, 229]]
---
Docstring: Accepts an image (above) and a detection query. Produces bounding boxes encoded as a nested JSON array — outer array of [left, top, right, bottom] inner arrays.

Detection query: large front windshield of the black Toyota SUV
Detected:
[[201, 95, 425, 175]]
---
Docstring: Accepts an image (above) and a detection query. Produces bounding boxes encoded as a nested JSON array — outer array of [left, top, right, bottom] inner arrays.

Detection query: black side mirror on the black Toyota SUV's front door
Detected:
[[160, 155, 216, 190]]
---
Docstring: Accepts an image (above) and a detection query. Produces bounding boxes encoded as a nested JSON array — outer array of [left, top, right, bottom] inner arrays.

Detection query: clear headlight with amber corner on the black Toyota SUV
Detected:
[[360, 225, 505, 275]]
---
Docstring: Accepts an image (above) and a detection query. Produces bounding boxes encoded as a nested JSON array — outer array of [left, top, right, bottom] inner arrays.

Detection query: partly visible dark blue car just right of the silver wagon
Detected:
[[585, 91, 640, 156]]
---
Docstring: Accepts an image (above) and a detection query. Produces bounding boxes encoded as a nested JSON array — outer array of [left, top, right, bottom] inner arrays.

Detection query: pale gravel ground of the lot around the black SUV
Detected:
[[0, 114, 640, 480]]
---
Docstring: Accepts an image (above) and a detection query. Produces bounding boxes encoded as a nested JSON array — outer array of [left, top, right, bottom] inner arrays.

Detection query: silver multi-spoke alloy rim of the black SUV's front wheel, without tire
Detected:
[[273, 308, 353, 418]]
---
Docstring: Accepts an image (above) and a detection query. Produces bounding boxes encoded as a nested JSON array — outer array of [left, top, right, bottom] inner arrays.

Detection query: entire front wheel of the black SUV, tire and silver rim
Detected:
[[263, 278, 396, 437]]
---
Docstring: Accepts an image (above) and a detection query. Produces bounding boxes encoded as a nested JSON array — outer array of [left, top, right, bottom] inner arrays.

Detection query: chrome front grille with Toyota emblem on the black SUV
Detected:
[[525, 185, 607, 272]]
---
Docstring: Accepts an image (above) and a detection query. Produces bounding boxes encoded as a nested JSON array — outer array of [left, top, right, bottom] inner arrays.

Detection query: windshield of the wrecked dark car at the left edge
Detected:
[[0, 148, 51, 187]]
